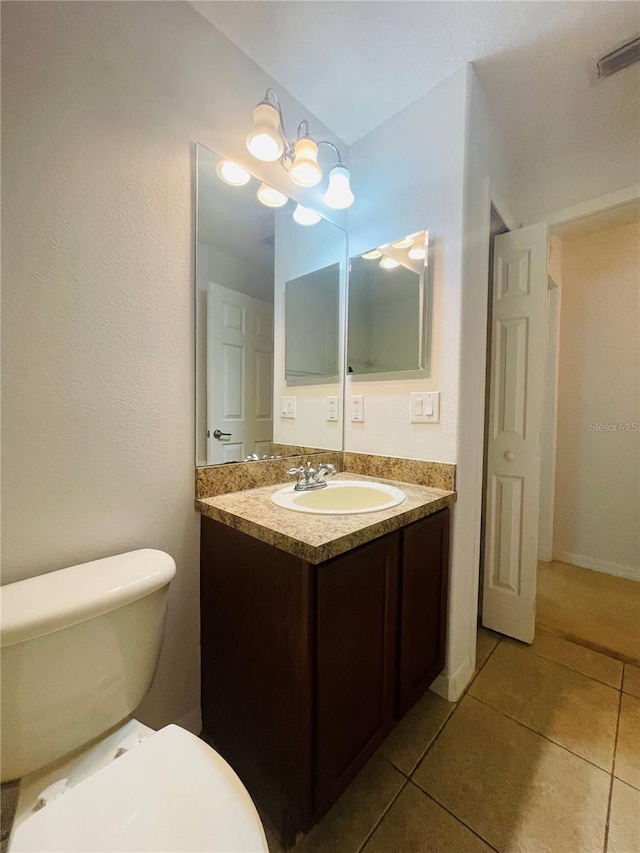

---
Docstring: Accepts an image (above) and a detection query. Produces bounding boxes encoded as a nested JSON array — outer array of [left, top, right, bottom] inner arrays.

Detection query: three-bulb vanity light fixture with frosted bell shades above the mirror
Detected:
[[247, 89, 354, 210]]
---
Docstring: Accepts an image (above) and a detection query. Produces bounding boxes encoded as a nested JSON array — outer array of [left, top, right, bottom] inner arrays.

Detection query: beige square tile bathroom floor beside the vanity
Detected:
[[268, 629, 640, 853]]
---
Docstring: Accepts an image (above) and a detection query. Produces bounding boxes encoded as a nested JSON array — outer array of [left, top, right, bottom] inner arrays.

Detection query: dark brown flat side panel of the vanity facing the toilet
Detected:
[[200, 518, 314, 843]]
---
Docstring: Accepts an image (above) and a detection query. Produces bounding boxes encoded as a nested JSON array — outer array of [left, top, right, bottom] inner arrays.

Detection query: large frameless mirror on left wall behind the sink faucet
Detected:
[[195, 144, 347, 466]]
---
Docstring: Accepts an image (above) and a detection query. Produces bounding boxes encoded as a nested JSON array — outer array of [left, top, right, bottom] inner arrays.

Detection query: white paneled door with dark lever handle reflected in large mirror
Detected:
[[207, 284, 273, 465]]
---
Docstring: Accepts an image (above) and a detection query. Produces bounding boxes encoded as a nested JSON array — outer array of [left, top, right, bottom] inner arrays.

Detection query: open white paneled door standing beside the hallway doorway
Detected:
[[482, 225, 548, 643]]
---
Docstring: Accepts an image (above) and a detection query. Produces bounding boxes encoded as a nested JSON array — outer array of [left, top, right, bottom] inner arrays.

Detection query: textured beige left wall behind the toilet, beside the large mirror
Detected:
[[2, 2, 344, 726]]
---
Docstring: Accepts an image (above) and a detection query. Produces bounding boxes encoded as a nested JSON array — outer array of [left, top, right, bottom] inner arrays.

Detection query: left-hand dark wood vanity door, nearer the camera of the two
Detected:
[[315, 533, 399, 819]]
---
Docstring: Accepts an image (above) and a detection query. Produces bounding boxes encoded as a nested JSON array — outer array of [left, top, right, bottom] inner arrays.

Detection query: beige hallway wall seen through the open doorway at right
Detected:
[[553, 224, 640, 580]]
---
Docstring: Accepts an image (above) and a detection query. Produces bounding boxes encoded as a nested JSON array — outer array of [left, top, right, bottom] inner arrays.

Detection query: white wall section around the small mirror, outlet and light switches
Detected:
[[345, 68, 466, 462]]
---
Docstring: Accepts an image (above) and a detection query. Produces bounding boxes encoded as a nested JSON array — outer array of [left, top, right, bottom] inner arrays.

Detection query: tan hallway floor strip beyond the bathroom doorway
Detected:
[[536, 560, 640, 666]]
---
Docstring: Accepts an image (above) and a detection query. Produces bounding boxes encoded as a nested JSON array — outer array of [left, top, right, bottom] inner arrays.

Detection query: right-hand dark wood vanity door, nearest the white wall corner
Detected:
[[398, 509, 449, 716]]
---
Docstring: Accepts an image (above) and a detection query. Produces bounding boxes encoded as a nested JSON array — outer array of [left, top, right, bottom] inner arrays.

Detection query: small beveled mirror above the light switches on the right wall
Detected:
[[347, 231, 430, 379]]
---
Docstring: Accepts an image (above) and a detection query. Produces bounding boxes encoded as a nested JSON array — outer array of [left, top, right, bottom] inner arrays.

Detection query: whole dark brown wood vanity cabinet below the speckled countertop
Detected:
[[201, 509, 449, 846]]
